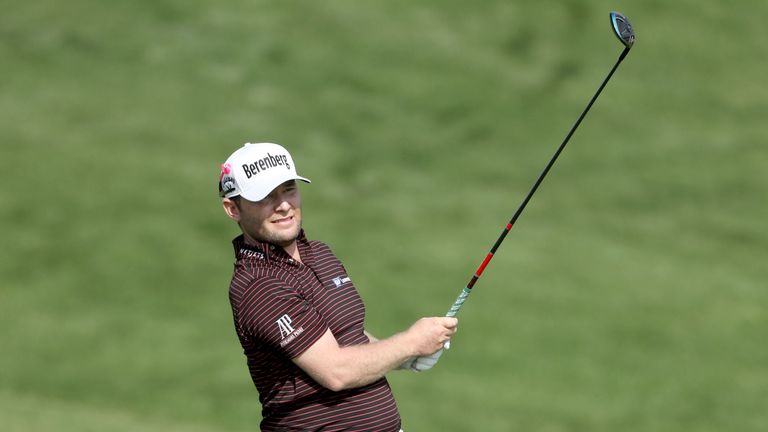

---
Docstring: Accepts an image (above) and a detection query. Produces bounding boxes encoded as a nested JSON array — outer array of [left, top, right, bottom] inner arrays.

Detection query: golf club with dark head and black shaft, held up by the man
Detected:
[[413, 12, 635, 370]]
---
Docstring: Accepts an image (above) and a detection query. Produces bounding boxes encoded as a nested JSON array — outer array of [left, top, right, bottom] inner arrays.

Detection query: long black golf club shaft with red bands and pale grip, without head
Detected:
[[446, 47, 629, 317]]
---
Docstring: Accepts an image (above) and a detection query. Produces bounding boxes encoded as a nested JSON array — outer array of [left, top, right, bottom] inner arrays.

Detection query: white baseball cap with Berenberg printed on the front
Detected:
[[219, 143, 311, 201]]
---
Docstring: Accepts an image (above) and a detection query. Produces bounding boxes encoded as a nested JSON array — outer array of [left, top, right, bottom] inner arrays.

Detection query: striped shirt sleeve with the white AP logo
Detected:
[[237, 278, 328, 359]]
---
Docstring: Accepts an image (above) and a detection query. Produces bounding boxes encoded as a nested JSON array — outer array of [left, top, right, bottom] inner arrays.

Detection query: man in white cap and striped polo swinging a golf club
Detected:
[[219, 143, 457, 431]]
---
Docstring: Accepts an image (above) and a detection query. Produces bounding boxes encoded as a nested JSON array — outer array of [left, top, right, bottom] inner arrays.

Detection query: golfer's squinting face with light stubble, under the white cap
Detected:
[[223, 180, 301, 247]]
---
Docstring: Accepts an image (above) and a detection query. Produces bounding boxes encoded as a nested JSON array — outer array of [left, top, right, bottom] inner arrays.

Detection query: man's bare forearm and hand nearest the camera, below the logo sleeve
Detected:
[[293, 317, 457, 391]]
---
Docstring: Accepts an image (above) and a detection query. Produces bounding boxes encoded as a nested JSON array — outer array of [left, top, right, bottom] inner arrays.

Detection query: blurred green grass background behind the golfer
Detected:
[[0, 0, 768, 432]]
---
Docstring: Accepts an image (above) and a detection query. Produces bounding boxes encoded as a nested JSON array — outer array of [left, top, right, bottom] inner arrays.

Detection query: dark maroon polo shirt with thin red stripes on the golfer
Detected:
[[229, 231, 400, 431]]
